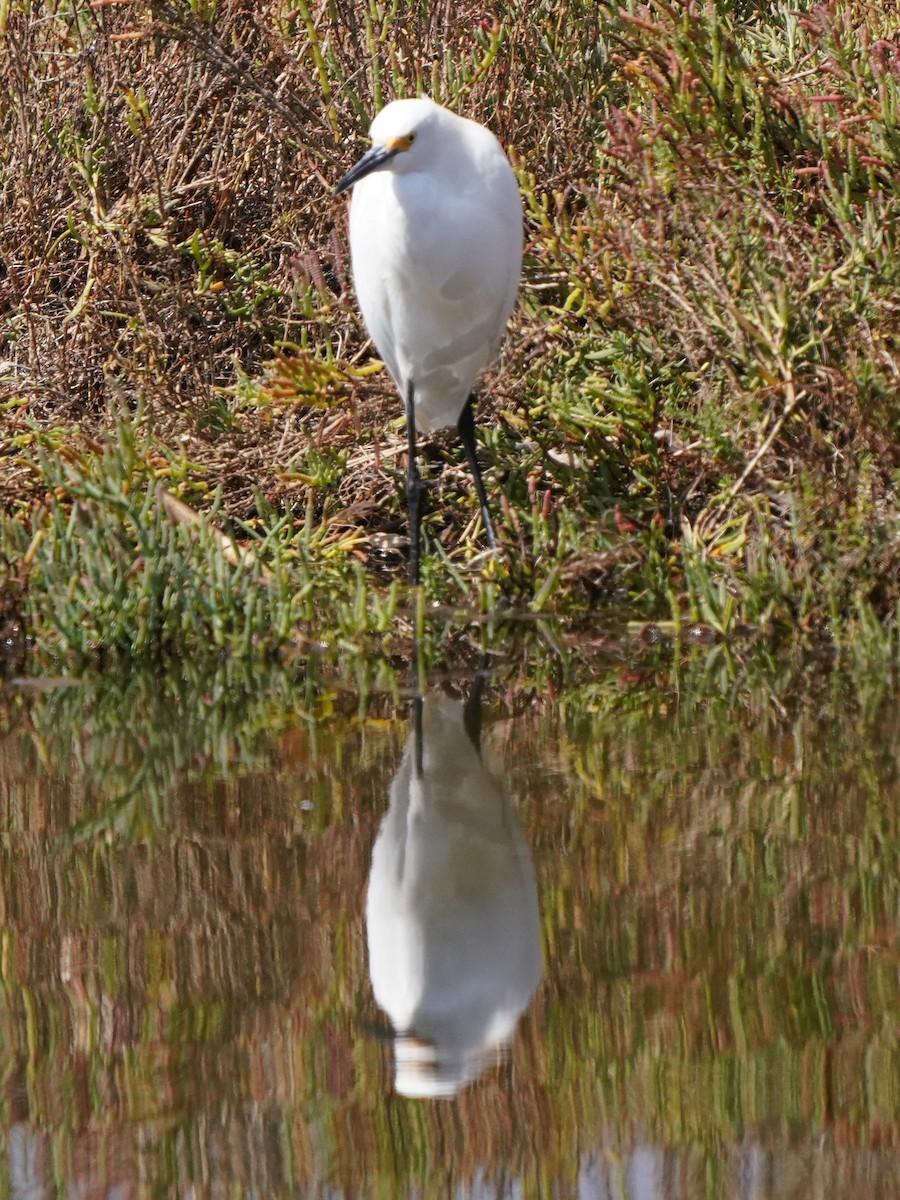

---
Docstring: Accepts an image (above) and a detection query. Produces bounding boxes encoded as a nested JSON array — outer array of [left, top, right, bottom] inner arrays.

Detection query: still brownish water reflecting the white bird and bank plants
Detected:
[[0, 648, 900, 1200]]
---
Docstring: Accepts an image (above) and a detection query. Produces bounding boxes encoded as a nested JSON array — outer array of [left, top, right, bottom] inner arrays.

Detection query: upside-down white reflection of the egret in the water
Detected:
[[366, 672, 542, 1097]]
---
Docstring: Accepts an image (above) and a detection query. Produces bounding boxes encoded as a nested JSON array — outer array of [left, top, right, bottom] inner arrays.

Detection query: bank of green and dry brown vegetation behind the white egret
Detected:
[[0, 0, 900, 659]]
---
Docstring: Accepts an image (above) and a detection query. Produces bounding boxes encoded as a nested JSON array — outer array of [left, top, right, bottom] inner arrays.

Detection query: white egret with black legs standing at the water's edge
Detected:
[[335, 97, 522, 583]]
